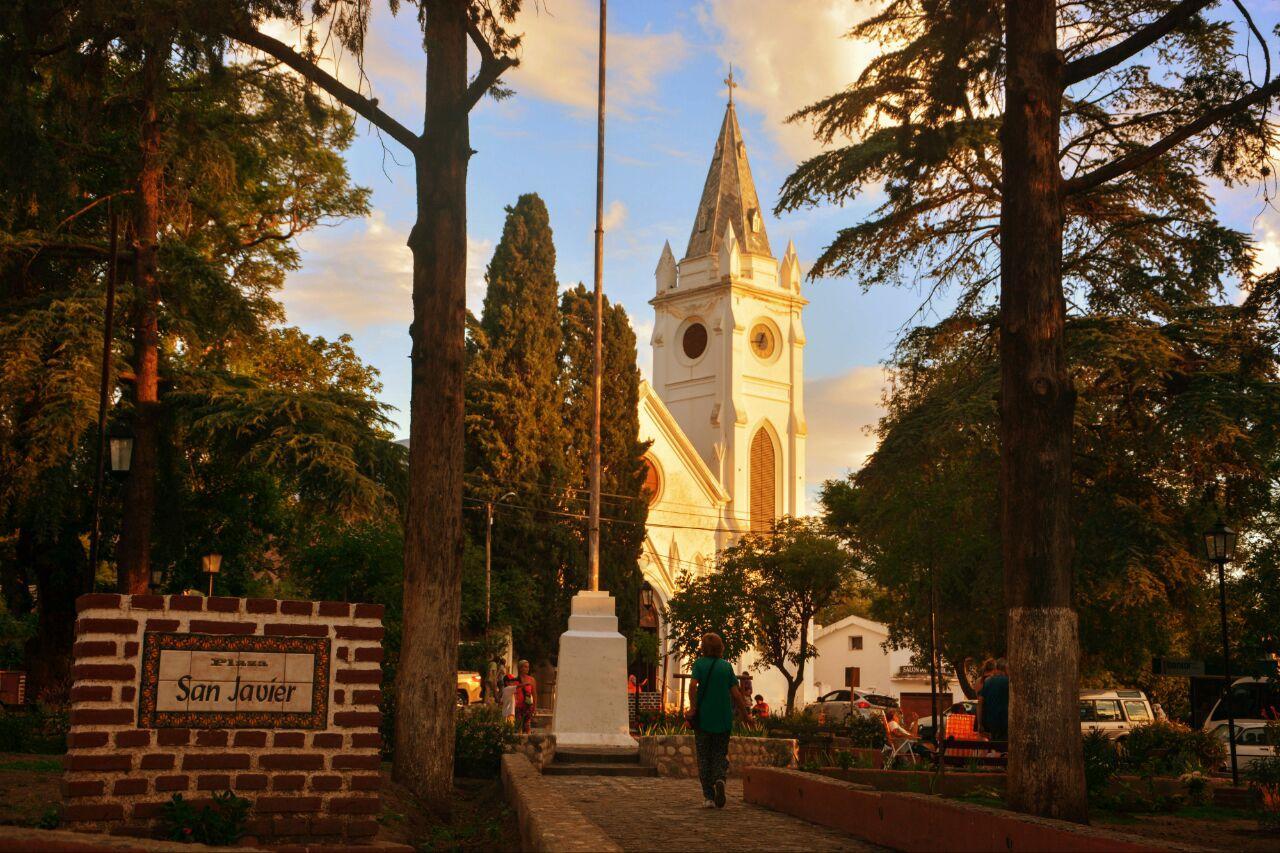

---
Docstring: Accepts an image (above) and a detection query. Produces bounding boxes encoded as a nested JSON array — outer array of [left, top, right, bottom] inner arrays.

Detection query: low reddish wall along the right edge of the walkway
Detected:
[[742, 767, 1203, 853]]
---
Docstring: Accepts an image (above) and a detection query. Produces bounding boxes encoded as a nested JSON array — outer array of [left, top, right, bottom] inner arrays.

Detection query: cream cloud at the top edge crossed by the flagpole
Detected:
[[504, 0, 689, 115]]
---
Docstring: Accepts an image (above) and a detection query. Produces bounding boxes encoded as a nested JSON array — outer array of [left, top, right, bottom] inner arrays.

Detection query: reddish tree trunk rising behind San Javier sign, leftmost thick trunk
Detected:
[[116, 46, 169, 593]]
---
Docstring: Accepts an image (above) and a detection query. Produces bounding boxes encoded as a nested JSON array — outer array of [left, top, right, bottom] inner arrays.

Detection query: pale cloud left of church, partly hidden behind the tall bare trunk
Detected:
[[280, 210, 493, 332]]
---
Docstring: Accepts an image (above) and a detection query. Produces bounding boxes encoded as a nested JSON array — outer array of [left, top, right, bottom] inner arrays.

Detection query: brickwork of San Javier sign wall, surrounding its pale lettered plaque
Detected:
[[63, 594, 383, 840]]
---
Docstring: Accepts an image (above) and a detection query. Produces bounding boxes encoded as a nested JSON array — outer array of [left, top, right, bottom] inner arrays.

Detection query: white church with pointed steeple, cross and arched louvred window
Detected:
[[640, 86, 813, 708]]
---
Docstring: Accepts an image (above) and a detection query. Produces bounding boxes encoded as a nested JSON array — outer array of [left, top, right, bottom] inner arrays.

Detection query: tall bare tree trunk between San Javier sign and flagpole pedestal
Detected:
[[394, 0, 471, 813]]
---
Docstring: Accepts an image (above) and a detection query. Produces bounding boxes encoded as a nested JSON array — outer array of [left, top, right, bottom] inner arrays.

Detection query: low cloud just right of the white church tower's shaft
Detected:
[[804, 366, 886, 491]]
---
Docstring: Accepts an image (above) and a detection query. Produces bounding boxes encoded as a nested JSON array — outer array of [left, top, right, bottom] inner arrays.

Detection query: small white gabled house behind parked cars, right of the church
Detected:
[[809, 616, 961, 717]]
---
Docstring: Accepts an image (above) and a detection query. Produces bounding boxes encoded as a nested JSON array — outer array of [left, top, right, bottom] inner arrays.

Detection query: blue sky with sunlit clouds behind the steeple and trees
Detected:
[[275, 0, 1280, 502]]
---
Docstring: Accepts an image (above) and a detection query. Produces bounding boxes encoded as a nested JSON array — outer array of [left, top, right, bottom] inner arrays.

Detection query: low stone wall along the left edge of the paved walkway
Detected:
[[502, 753, 622, 853]]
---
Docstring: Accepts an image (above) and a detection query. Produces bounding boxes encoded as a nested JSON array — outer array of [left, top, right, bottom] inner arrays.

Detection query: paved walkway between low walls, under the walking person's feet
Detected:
[[543, 776, 883, 853]]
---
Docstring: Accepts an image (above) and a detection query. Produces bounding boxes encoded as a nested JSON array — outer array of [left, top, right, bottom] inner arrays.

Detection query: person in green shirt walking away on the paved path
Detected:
[[686, 634, 748, 808]]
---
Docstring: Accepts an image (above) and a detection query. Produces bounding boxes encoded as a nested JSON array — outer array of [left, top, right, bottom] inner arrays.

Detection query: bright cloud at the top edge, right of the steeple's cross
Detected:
[[699, 0, 881, 160]]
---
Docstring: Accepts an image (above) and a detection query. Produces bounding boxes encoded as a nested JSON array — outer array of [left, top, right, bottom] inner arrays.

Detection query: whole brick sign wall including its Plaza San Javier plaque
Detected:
[[64, 594, 383, 840]]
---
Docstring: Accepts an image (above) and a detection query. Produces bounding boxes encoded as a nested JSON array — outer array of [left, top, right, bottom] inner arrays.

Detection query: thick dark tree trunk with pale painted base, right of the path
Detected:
[[1000, 0, 1088, 822]]
